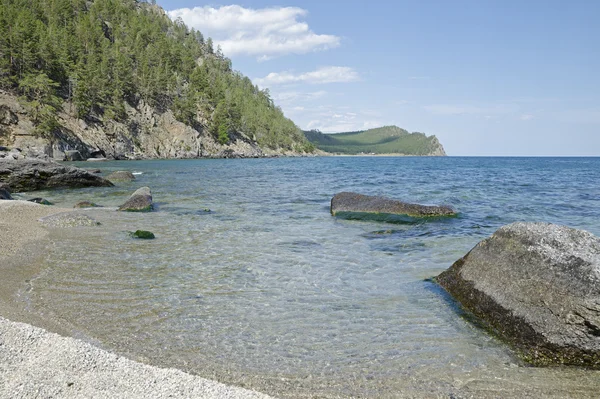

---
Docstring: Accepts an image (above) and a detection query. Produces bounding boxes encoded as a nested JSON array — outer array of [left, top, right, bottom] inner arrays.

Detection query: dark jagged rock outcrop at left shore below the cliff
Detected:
[[0, 159, 113, 192]]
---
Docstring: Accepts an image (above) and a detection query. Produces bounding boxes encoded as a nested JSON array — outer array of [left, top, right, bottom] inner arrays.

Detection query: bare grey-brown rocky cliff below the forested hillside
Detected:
[[0, 91, 297, 159]]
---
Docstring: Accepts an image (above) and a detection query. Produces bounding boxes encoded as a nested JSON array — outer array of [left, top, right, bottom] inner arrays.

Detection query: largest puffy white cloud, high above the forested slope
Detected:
[[168, 5, 340, 60]]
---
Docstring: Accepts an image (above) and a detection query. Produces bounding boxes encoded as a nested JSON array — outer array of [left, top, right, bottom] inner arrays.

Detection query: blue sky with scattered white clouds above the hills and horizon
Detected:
[[158, 0, 600, 156]]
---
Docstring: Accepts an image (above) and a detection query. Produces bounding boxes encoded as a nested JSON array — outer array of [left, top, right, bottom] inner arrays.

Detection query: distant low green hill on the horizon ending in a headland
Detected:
[[304, 126, 446, 156]]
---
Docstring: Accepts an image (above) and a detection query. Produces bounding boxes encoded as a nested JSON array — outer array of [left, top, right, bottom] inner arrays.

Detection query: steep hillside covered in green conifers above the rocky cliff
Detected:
[[0, 0, 312, 159]]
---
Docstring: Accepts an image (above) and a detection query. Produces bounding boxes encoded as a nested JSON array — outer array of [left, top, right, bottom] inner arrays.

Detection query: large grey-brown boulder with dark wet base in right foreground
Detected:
[[436, 223, 600, 368]]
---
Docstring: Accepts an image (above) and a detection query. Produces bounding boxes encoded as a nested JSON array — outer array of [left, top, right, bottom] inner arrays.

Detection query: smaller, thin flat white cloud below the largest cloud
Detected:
[[254, 66, 359, 87]]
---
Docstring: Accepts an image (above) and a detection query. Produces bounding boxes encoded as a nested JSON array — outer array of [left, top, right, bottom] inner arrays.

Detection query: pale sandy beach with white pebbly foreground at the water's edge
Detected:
[[0, 201, 269, 398]]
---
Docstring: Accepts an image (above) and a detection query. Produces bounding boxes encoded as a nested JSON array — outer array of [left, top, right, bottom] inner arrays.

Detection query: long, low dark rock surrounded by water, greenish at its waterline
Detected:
[[331, 192, 456, 218]]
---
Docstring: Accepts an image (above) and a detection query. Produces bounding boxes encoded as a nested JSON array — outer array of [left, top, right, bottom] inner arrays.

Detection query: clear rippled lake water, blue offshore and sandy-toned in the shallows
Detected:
[[21, 157, 600, 398]]
